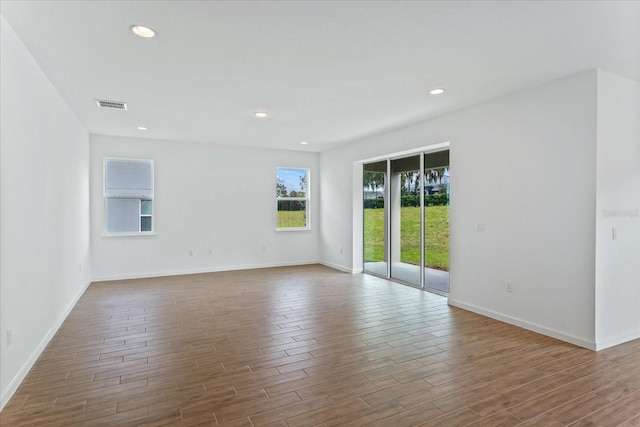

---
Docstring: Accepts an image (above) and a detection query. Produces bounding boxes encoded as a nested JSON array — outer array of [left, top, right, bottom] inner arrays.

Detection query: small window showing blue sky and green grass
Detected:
[[276, 168, 310, 230]]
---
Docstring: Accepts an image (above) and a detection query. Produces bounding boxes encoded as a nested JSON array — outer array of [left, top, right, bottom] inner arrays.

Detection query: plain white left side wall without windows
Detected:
[[0, 18, 91, 407]]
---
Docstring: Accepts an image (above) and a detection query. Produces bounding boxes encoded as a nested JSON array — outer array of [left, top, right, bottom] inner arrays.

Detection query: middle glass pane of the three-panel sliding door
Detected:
[[390, 155, 421, 286]]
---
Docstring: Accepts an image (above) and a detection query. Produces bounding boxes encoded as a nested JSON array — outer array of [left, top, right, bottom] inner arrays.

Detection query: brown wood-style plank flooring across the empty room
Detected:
[[0, 266, 640, 427]]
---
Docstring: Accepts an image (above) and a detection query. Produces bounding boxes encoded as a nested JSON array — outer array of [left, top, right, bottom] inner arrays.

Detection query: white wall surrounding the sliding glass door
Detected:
[[320, 71, 597, 347]]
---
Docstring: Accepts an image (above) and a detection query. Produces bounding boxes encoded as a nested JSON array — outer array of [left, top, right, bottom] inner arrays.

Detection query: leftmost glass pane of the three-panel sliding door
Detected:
[[362, 161, 387, 277]]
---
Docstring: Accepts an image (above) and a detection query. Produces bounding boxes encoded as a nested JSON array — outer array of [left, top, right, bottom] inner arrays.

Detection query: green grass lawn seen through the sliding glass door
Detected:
[[364, 206, 449, 271]]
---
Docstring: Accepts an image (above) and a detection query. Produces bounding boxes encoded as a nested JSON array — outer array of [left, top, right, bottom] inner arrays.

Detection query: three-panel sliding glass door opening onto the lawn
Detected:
[[363, 150, 450, 294]]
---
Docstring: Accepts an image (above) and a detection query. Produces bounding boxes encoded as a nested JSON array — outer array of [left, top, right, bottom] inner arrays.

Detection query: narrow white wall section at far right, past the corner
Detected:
[[596, 70, 640, 349]]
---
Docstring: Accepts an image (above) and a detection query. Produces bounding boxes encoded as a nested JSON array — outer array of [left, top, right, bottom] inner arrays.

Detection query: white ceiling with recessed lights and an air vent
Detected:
[[0, 0, 640, 151]]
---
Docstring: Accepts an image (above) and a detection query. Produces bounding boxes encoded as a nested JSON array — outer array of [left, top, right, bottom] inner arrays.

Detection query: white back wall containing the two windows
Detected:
[[91, 135, 319, 280]]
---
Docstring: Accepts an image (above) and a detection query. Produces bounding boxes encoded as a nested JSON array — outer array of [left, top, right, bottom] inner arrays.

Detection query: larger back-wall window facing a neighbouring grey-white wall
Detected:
[[104, 159, 153, 234]]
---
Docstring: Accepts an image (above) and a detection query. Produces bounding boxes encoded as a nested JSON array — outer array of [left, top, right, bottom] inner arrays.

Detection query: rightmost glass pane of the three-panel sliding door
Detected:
[[424, 156, 449, 293]]
